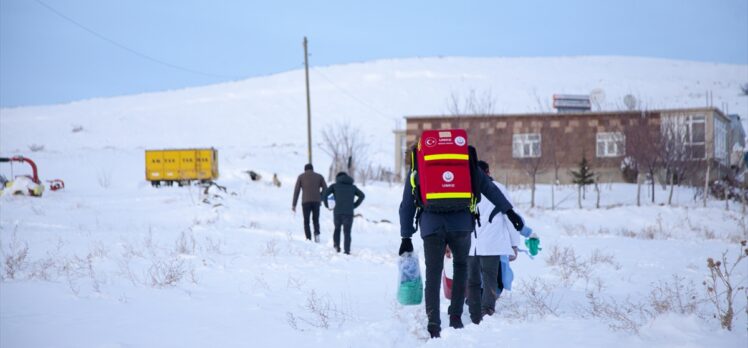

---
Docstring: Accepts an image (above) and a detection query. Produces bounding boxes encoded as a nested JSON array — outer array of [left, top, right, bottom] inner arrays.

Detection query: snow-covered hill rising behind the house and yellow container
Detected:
[[0, 57, 748, 166]]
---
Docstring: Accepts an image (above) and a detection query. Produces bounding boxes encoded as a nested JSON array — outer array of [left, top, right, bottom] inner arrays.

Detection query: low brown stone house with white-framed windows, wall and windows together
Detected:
[[395, 107, 734, 184]]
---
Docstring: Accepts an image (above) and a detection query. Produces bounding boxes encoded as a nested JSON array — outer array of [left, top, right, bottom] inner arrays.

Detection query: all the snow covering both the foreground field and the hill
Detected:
[[0, 57, 748, 347]]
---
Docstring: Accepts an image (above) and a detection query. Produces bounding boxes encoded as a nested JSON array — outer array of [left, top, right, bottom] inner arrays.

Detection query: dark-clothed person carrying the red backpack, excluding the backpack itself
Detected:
[[399, 150, 524, 338]]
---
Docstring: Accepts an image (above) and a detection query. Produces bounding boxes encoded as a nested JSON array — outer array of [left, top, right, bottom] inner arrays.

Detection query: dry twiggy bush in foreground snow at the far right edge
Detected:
[[703, 240, 748, 331]]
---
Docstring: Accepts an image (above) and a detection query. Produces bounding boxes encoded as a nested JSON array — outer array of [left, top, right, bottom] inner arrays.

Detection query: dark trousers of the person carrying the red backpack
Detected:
[[423, 230, 470, 327]]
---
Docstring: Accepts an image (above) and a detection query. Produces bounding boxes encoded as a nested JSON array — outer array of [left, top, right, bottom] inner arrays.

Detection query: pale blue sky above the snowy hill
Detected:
[[0, 0, 748, 107]]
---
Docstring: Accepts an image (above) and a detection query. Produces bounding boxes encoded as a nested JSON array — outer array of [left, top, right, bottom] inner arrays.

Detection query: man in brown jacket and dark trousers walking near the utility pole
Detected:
[[291, 163, 327, 243]]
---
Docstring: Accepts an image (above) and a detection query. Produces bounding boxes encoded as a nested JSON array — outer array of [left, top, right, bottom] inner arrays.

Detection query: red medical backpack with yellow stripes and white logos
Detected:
[[410, 129, 481, 220]]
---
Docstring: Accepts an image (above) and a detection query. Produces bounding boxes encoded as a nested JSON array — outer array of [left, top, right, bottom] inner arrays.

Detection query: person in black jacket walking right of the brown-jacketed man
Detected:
[[322, 172, 364, 254]]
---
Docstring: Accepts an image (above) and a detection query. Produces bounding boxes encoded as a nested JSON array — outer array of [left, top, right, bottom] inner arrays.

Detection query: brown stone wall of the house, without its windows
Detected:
[[404, 108, 724, 184]]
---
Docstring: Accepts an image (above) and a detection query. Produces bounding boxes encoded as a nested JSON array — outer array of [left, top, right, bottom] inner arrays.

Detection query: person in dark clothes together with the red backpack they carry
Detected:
[[399, 129, 524, 338]]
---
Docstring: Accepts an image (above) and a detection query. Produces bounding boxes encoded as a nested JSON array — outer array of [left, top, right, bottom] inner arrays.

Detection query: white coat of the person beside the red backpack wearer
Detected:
[[469, 181, 520, 256]]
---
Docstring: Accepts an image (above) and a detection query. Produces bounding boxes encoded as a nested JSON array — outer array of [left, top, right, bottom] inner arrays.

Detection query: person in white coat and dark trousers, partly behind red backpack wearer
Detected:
[[467, 161, 520, 324]]
